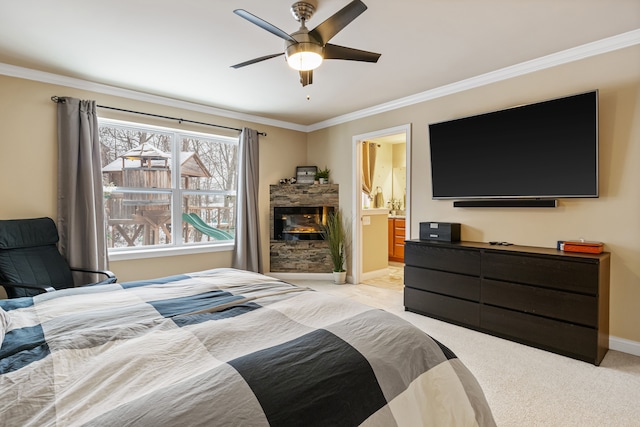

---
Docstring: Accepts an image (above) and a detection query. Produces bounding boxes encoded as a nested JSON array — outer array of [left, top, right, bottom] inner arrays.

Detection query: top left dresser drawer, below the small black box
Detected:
[[404, 242, 480, 276]]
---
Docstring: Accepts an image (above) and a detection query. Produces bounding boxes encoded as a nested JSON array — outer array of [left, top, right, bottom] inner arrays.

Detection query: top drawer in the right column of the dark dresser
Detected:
[[482, 252, 599, 295]]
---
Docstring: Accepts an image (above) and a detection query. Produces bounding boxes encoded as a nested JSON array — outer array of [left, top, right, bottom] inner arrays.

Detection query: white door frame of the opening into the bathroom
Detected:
[[351, 124, 411, 284]]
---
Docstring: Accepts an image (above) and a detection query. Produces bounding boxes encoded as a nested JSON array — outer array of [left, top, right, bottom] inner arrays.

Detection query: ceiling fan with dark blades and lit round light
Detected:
[[231, 0, 380, 86]]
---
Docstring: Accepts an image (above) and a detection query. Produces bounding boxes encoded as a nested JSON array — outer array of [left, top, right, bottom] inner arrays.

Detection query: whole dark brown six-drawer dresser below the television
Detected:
[[404, 240, 610, 365]]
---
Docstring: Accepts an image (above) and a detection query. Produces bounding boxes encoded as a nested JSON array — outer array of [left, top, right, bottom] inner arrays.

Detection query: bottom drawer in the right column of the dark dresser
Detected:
[[480, 306, 600, 365]]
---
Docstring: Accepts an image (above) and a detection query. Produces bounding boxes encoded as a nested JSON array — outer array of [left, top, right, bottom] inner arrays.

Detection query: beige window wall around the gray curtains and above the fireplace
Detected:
[[0, 76, 307, 281]]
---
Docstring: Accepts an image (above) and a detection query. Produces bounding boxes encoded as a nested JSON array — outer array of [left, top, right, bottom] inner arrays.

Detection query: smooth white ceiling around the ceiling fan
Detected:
[[0, 0, 640, 126]]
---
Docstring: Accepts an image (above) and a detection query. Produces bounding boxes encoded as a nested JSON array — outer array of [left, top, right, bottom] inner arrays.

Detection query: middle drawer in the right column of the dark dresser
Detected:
[[482, 279, 598, 327]]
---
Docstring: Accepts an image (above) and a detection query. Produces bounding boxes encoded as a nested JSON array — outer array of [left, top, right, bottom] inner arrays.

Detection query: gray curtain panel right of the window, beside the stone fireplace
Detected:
[[232, 128, 264, 273]]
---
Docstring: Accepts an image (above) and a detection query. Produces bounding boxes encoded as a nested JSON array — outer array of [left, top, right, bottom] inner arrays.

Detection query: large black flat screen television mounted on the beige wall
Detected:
[[429, 90, 598, 199]]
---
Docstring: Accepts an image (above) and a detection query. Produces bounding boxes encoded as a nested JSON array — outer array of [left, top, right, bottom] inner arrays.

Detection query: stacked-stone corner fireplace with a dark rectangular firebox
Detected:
[[269, 184, 339, 273]]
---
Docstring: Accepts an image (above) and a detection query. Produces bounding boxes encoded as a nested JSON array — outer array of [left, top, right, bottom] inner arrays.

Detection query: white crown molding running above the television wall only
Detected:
[[307, 29, 640, 132]]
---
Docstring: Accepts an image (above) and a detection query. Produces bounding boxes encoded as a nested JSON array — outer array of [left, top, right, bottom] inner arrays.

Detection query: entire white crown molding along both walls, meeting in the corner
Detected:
[[0, 29, 640, 133]]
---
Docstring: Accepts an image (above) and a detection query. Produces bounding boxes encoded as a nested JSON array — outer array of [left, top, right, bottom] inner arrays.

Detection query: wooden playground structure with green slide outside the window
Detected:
[[102, 144, 234, 247]]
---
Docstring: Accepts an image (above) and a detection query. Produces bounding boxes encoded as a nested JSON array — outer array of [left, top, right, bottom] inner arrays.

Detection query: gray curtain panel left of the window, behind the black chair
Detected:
[[58, 97, 108, 283]]
